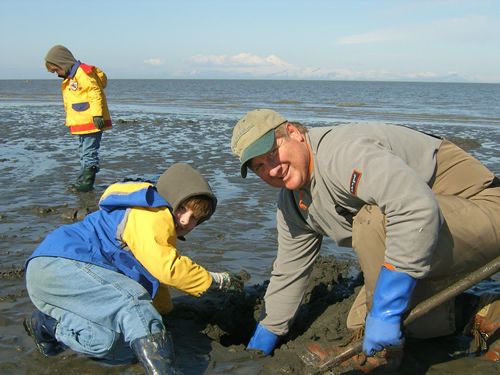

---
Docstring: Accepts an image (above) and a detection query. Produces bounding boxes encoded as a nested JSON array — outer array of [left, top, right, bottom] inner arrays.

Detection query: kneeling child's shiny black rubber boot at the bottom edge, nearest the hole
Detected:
[[130, 332, 181, 375]]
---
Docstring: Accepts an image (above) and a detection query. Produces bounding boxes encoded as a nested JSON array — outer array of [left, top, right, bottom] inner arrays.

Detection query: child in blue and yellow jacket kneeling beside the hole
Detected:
[[24, 163, 243, 374]]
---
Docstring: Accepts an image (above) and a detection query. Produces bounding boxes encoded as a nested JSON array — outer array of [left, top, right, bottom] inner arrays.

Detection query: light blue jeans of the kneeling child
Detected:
[[26, 257, 165, 362]]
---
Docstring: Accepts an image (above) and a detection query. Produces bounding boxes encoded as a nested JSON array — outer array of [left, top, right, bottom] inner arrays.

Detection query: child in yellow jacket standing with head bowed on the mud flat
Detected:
[[45, 45, 111, 192]]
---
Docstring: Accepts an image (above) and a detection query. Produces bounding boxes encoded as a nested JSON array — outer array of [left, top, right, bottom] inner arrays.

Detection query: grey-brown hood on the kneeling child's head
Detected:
[[156, 163, 217, 219]]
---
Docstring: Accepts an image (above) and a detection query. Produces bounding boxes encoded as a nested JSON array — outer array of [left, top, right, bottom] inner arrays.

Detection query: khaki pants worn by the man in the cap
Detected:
[[347, 141, 500, 338]]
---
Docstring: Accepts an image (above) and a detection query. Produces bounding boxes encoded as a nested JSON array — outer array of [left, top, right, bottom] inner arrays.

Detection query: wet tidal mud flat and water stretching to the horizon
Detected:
[[0, 80, 500, 375]]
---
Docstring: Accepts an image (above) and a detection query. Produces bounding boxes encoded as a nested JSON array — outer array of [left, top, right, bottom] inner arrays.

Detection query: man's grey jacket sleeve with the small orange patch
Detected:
[[321, 138, 442, 278]]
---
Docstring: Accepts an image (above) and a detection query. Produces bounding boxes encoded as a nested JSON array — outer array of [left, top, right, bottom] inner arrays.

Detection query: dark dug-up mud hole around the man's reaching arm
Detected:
[[165, 257, 362, 374]]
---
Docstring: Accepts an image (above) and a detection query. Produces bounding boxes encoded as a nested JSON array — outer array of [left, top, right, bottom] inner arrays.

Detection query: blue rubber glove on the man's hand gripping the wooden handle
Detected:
[[363, 266, 417, 356]]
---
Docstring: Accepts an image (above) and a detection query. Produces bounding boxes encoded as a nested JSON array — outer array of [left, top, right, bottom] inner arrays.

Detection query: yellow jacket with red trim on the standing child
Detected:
[[61, 61, 112, 134]]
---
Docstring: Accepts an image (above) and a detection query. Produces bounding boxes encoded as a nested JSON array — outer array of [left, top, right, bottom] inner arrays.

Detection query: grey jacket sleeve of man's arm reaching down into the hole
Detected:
[[261, 191, 322, 336]]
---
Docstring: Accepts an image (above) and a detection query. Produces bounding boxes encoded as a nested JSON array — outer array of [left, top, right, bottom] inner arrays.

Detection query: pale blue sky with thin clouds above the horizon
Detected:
[[0, 0, 500, 83]]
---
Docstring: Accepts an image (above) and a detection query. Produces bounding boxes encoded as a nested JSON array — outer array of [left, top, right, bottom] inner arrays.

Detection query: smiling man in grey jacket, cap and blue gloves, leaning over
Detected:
[[231, 109, 500, 370]]
